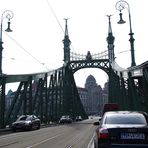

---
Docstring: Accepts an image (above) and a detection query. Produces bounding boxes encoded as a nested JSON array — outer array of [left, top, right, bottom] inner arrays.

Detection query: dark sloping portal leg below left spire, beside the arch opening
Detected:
[[63, 66, 88, 119]]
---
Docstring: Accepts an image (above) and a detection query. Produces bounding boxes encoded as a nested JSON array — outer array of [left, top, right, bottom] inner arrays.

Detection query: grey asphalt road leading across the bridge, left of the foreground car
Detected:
[[0, 119, 96, 148]]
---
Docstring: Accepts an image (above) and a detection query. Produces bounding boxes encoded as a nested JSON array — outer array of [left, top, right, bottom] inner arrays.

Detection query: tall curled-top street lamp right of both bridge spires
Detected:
[[115, 0, 136, 66]]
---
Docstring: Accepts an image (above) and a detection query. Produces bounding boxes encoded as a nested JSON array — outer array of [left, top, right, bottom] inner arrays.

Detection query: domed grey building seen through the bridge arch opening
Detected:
[[78, 75, 108, 115]]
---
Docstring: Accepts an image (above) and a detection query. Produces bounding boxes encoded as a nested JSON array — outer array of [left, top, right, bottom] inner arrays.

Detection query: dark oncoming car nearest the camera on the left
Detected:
[[12, 115, 41, 131]]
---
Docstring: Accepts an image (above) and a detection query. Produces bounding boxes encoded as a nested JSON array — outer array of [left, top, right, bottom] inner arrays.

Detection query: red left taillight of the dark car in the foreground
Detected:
[[97, 128, 109, 139]]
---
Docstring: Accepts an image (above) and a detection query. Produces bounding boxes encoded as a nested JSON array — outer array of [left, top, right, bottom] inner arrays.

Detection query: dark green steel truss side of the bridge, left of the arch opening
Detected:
[[0, 67, 87, 128]]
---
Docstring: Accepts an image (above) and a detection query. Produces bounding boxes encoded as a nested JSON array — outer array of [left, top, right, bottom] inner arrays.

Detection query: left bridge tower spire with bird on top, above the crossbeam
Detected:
[[63, 19, 71, 63]]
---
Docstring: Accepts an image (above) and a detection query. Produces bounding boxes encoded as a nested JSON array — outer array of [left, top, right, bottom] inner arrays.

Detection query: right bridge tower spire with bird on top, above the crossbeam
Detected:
[[106, 15, 115, 63]]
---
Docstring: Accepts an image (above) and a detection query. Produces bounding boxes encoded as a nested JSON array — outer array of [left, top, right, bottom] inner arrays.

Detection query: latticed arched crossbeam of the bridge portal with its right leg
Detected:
[[66, 59, 120, 102]]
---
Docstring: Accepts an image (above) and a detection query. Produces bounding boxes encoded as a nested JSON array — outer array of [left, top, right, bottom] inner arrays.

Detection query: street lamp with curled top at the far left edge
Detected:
[[0, 10, 13, 74]]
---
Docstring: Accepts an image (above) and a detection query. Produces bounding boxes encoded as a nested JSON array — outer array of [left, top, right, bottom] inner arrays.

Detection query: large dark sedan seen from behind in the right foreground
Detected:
[[94, 111, 148, 148]]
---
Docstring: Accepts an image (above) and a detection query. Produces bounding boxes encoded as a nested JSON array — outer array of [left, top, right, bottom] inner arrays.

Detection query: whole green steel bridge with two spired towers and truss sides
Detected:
[[0, 16, 148, 128]]
